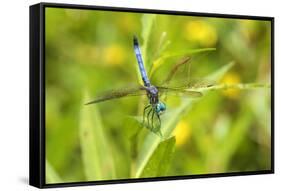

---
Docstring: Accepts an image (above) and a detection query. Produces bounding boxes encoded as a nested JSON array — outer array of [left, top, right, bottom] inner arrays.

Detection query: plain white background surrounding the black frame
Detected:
[[0, 0, 276, 191]]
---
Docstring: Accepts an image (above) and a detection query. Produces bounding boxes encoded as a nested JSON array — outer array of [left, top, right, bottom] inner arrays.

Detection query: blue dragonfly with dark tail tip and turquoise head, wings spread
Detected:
[[85, 36, 202, 135]]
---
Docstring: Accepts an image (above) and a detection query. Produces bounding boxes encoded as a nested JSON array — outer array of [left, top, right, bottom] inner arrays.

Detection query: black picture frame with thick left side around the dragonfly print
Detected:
[[29, 3, 274, 188]]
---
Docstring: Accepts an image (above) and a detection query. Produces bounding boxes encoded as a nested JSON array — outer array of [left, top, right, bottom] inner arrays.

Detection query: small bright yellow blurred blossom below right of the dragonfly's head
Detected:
[[174, 120, 191, 146]]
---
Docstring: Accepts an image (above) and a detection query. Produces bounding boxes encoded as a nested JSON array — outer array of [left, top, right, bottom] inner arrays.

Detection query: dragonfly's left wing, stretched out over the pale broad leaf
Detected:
[[85, 87, 146, 105]]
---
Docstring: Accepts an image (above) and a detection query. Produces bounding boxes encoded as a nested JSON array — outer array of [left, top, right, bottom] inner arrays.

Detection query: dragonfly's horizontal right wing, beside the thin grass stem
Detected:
[[157, 86, 203, 97]]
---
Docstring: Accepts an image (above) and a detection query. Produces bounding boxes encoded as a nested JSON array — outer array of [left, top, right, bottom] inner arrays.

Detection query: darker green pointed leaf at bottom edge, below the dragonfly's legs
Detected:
[[140, 137, 176, 177]]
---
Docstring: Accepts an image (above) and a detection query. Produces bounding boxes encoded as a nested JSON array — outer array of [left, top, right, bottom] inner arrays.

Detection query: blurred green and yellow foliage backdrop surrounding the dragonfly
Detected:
[[45, 8, 271, 183]]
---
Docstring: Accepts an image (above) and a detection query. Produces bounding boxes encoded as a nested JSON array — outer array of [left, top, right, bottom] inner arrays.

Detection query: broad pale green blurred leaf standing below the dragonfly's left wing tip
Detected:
[[80, 95, 116, 180]]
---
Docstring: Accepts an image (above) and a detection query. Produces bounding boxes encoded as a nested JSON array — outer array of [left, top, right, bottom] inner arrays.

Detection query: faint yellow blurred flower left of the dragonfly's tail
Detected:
[[103, 44, 125, 65]]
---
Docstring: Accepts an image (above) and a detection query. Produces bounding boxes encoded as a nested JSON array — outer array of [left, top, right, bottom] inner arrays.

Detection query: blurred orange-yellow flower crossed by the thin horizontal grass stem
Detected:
[[221, 72, 240, 99]]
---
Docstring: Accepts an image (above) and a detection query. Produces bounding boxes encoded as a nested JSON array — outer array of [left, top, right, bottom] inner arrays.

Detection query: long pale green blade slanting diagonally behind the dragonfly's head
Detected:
[[135, 59, 232, 177]]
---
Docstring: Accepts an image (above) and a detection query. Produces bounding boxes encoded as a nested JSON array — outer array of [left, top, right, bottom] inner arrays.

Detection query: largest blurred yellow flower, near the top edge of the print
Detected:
[[184, 20, 218, 47]]
